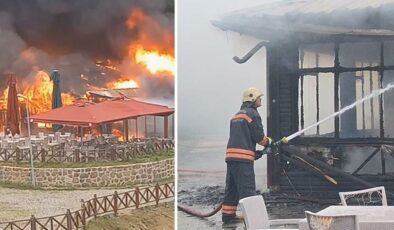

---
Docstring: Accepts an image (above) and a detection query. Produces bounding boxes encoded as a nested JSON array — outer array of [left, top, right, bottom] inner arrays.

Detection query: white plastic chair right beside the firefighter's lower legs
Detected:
[[239, 195, 301, 230]]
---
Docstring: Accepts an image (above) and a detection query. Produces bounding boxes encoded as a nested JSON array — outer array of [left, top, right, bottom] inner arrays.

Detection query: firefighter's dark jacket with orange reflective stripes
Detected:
[[226, 102, 269, 162]]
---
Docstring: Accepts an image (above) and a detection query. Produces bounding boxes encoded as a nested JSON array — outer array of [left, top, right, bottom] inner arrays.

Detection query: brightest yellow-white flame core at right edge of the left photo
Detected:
[[135, 47, 175, 75]]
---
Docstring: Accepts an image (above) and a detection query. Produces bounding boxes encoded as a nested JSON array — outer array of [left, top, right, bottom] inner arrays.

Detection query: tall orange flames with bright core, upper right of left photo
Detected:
[[96, 8, 175, 90]]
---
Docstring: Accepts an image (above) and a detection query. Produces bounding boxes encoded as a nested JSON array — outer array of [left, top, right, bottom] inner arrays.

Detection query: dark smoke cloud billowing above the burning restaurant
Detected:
[[0, 0, 174, 98]]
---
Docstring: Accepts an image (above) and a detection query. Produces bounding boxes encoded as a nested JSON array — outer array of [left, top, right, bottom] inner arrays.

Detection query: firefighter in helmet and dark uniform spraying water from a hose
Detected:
[[222, 88, 272, 224]]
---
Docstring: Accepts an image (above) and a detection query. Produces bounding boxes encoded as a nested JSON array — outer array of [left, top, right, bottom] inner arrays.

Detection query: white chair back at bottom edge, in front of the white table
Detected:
[[305, 211, 359, 230]]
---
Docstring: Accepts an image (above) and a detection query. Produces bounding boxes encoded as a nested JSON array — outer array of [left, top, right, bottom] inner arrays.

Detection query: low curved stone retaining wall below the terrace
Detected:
[[0, 159, 175, 188]]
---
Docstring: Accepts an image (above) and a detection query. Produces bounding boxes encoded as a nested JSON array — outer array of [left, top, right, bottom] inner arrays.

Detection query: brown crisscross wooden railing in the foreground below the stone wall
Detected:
[[0, 183, 175, 230]]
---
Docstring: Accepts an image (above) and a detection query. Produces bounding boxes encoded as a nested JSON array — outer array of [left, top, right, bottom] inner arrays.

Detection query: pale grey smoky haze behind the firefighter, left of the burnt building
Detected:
[[176, 0, 282, 205]]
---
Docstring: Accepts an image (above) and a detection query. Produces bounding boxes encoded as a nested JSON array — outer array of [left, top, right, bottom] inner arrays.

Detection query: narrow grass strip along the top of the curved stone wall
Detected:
[[0, 150, 174, 168]]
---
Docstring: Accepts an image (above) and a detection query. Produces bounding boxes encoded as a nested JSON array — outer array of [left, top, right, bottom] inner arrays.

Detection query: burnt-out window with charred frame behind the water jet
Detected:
[[298, 42, 394, 138]]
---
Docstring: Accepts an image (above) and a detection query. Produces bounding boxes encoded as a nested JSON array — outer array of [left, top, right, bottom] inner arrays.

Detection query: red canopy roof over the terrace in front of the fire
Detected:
[[31, 99, 174, 126]]
